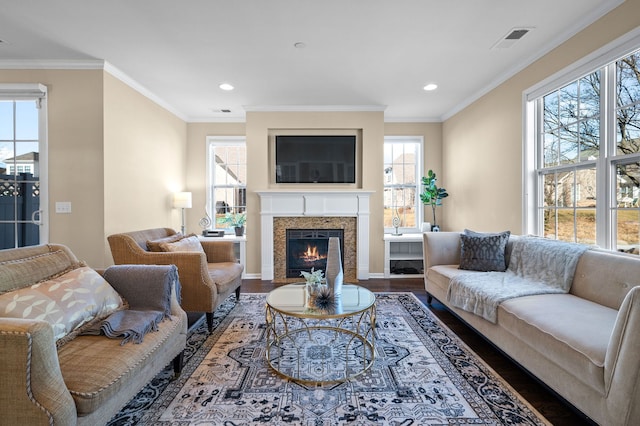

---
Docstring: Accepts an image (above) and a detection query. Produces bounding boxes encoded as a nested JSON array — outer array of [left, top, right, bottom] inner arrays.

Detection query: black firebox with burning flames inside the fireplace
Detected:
[[286, 229, 344, 278]]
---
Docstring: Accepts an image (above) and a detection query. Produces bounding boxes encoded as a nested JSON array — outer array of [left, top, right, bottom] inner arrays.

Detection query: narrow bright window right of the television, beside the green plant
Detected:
[[384, 136, 422, 232]]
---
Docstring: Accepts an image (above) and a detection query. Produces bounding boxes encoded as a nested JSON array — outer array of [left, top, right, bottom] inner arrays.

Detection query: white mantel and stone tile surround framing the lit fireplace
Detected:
[[257, 190, 373, 282]]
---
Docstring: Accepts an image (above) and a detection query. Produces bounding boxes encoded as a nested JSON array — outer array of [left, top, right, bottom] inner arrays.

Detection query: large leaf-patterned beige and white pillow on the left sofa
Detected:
[[0, 266, 124, 340]]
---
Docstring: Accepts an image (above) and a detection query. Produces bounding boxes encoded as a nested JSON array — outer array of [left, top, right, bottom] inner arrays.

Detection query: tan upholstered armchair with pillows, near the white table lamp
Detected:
[[107, 228, 244, 331]]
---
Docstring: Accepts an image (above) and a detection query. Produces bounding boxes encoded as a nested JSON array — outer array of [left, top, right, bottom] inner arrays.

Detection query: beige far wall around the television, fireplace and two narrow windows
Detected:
[[186, 116, 442, 276]]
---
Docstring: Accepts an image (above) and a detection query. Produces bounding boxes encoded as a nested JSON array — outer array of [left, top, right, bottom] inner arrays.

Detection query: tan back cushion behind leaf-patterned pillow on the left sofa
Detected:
[[0, 250, 80, 293]]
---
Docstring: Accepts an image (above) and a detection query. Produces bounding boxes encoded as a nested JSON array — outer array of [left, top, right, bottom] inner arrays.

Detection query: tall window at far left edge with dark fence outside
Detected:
[[0, 84, 48, 249]]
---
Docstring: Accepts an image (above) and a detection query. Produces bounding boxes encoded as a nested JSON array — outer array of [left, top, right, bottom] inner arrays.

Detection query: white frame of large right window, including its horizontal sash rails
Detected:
[[522, 28, 640, 250]]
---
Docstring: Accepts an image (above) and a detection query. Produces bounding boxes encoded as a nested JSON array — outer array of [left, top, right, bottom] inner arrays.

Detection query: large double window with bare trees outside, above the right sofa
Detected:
[[525, 41, 640, 254]]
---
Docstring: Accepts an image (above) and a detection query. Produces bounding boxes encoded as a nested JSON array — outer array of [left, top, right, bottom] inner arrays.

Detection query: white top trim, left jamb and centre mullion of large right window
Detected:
[[522, 27, 640, 249]]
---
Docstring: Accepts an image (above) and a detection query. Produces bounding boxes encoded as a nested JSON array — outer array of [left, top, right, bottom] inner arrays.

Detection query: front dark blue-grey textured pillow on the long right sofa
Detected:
[[459, 229, 511, 272]]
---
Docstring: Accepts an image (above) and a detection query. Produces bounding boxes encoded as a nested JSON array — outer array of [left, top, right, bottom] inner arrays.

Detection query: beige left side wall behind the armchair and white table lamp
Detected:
[[103, 73, 190, 264]]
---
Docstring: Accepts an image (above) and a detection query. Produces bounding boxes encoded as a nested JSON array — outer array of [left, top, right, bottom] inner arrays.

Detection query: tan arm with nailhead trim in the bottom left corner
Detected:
[[0, 318, 77, 425]]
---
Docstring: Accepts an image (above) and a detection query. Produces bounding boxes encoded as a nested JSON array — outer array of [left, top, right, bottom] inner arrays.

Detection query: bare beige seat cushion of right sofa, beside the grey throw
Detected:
[[498, 294, 618, 392]]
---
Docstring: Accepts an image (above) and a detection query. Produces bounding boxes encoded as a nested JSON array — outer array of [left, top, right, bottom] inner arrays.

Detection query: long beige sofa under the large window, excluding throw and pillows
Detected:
[[424, 232, 640, 426]]
